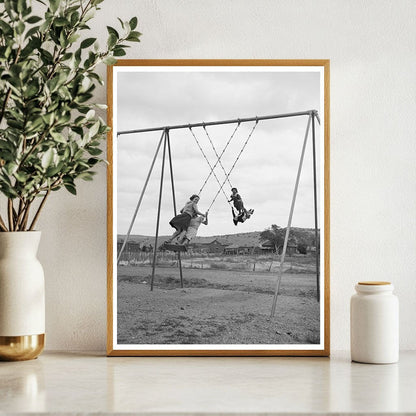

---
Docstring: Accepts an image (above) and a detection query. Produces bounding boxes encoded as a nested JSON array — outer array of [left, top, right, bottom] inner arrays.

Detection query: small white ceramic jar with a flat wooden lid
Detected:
[[351, 282, 399, 364]]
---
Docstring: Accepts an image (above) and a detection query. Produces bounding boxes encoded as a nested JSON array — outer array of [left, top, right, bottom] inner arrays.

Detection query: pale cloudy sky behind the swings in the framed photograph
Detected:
[[114, 67, 322, 236]]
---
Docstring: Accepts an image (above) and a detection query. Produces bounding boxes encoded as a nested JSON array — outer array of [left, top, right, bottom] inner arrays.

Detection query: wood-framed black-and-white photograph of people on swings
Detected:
[[107, 60, 330, 356]]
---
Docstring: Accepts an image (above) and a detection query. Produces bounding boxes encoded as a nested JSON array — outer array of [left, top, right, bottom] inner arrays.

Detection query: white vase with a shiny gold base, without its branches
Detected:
[[0, 231, 45, 361]]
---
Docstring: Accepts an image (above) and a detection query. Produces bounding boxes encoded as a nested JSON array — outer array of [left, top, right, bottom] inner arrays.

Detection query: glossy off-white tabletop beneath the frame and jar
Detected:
[[0, 351, 416, 416]]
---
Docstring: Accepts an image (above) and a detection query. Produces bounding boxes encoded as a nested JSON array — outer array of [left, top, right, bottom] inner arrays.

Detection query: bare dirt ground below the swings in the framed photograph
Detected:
[[117, 266, 320, 344]]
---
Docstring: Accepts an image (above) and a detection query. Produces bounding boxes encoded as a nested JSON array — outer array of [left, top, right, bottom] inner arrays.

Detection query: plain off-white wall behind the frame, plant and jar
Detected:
[[39, 0, 416, 350]]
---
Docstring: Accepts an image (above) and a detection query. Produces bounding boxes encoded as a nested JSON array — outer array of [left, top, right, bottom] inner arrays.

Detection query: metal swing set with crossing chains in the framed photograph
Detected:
[[117, 110, 320, 317]]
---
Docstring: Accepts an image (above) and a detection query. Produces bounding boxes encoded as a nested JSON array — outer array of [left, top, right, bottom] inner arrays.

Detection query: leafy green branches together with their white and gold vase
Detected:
[[0, 0, 140, 360]]
